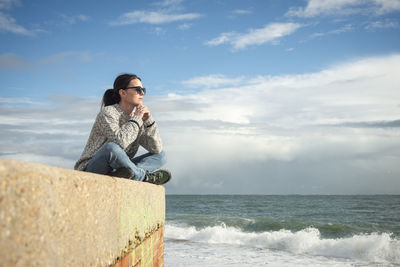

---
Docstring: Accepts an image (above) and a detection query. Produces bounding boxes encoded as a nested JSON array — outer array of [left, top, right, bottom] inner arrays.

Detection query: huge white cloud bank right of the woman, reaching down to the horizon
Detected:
[[155, 55, 400, 193]]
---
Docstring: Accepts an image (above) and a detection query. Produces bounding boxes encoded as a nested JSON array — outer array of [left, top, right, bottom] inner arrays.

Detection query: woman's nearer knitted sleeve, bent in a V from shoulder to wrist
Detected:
[[98, 110, 143, 149]]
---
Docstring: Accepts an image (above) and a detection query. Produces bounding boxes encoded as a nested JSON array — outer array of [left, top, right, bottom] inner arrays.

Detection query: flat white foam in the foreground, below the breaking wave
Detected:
[[164, 239, 356, 267]]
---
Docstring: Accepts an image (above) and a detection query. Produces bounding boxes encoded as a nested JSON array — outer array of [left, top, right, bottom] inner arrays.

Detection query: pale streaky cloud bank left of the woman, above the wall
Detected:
[[0, 96, 99, 171]]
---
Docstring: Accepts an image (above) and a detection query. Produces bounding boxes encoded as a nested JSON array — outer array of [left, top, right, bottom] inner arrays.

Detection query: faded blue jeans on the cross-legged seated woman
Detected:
[[85, 142, 166, 181]]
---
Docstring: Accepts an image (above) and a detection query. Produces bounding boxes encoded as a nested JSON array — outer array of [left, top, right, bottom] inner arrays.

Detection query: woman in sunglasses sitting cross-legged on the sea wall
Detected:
[[74, 74, 171, 184]]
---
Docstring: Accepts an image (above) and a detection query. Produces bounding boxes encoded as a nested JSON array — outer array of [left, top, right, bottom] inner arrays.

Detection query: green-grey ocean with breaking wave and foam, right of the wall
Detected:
[[164, 195, 400, 267]]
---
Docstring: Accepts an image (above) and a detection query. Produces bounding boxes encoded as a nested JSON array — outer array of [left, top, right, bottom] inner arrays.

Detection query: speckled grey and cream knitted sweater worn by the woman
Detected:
[[74, 104, 162, 171]]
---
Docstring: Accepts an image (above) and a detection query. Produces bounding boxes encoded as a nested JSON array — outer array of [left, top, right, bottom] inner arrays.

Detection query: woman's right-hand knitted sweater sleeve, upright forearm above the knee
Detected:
[[140, 116, 162, 153]]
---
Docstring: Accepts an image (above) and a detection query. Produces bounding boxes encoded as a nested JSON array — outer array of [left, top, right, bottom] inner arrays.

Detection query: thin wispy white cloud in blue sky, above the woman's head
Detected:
[[110, 10, 201, 26]]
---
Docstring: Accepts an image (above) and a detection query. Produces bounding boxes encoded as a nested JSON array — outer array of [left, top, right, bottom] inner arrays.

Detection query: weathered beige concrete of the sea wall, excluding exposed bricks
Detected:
[[0, 159, 165, 266]]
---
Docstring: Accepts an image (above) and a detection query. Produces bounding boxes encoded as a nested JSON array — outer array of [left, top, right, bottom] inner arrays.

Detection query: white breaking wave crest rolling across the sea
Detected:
[[165, 223, 400, 264]]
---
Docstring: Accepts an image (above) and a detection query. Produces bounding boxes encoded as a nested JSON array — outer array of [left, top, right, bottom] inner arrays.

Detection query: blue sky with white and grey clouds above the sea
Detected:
[[0, 0, 400, 194]]
